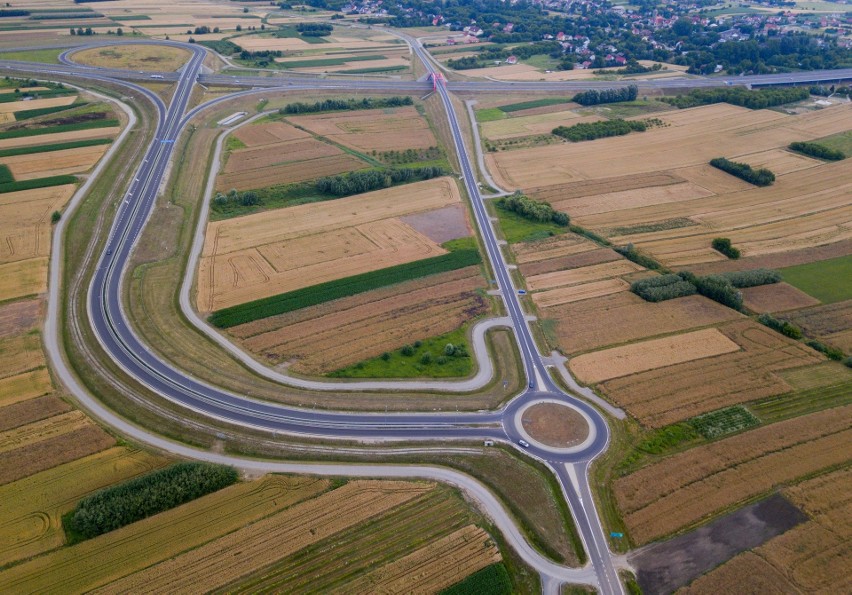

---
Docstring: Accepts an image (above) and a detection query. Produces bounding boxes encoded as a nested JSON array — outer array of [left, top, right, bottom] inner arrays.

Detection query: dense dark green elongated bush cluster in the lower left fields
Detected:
[[70, 463, 239, 539]]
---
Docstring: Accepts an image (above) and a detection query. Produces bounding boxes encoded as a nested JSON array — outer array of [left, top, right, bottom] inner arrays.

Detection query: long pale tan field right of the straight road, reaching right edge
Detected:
[[486, 103, 852, 188]]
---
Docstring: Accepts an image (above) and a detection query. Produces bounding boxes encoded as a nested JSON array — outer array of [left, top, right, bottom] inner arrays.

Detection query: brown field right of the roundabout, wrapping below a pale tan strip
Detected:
[[598, 321, 824, 427]]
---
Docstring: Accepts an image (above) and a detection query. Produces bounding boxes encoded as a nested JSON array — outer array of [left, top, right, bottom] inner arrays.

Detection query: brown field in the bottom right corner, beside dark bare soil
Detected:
[[682, 467, 852, 595]]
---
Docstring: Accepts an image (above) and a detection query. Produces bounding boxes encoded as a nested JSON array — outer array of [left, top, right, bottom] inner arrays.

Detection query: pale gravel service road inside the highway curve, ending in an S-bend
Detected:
[[178, 111, 512, 393]]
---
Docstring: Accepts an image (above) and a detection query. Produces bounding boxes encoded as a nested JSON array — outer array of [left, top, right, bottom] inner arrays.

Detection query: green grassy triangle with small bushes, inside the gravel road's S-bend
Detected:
[[328, 328, 473, 378]]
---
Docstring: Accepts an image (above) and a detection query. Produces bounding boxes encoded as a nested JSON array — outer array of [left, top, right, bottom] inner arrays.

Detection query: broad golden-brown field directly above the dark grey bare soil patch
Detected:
[[614, 406, 852, 543]]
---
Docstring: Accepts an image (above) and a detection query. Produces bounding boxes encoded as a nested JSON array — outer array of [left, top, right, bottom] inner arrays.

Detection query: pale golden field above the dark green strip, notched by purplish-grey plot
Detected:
[[198, 178, 461, 312]]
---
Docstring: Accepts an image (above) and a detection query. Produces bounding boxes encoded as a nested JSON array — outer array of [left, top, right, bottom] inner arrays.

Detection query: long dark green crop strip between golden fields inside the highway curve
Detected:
[[208, 249, 482, 328]]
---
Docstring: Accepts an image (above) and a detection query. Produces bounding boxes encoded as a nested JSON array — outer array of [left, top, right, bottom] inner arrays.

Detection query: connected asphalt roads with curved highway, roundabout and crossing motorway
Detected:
[[6, 42, 852, 593]]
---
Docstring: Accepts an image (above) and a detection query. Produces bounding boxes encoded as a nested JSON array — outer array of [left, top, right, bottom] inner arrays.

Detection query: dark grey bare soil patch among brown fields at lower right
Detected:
[[629, 494, 808, 593]]
